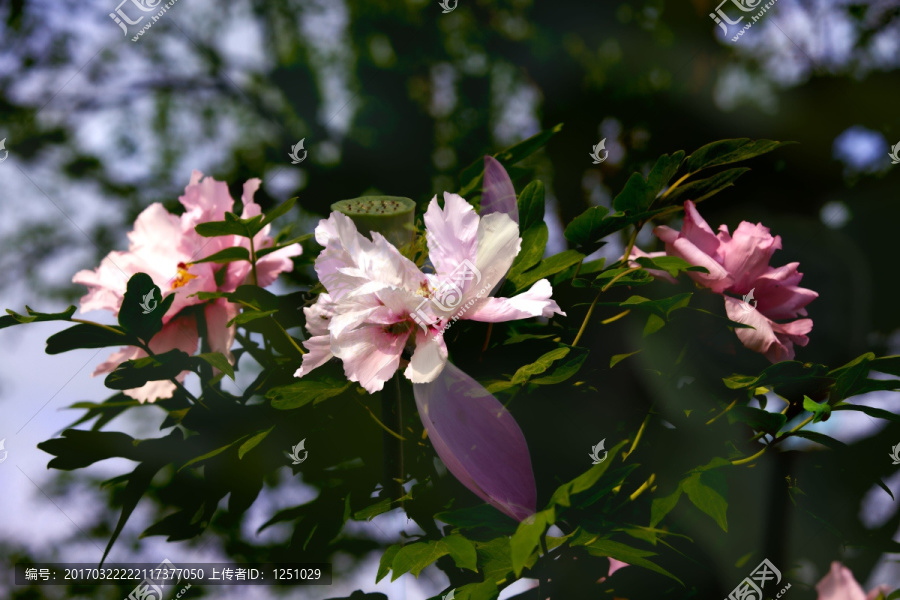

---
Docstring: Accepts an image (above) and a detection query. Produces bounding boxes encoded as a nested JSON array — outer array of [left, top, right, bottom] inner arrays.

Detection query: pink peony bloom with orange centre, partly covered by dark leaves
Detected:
[[72, 171, 302, 402]]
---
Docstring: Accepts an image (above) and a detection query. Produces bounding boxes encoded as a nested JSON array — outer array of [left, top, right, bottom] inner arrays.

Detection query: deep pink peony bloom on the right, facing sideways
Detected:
[[653, 201, 818, 362]]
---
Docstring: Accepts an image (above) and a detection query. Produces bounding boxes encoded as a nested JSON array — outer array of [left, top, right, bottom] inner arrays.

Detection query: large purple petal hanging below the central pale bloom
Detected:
[[413, 362, 537, 521]]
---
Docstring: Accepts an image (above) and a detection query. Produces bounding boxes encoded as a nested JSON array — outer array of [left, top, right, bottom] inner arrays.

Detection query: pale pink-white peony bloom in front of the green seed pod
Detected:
[[295, 193, 564, 393]]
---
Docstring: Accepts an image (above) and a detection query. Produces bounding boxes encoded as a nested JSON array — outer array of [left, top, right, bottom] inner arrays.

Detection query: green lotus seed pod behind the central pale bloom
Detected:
[[331, 196, 416, 248]]
